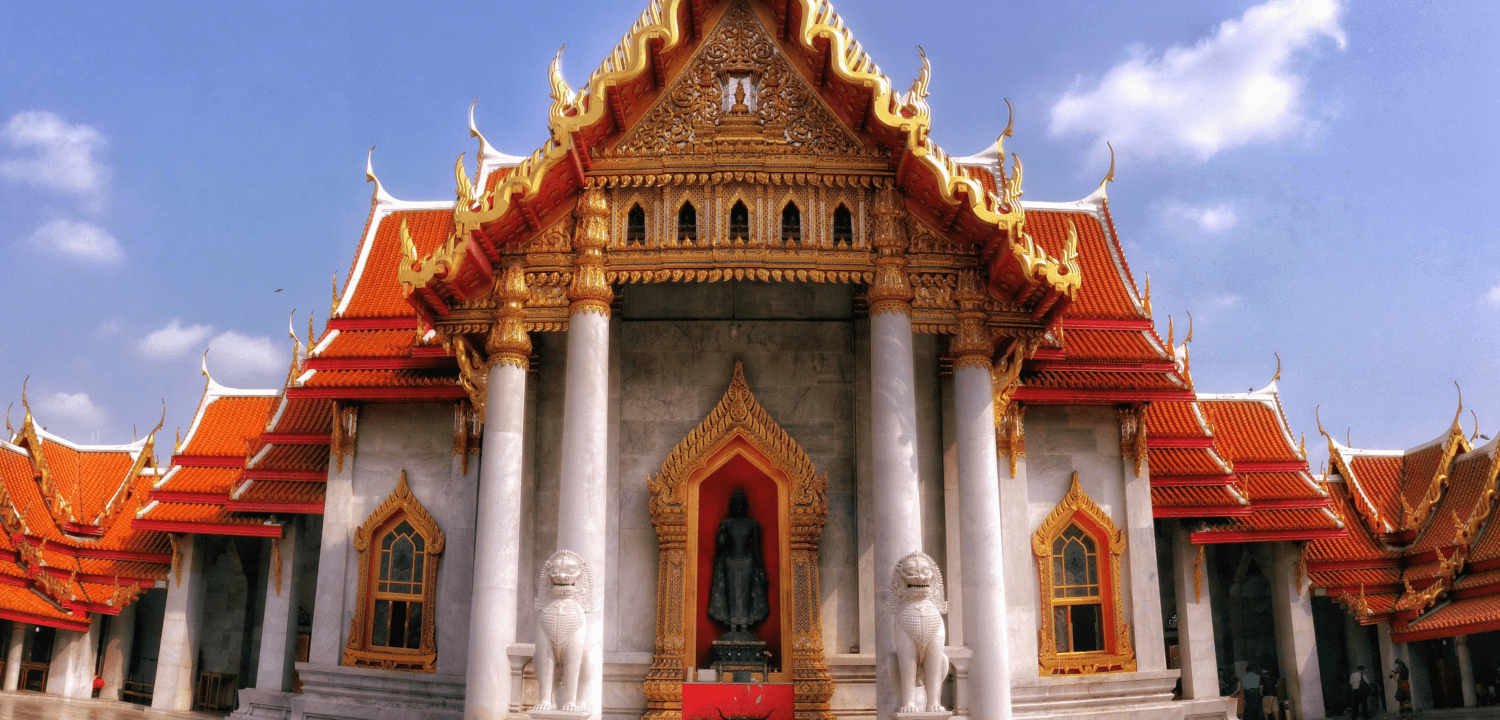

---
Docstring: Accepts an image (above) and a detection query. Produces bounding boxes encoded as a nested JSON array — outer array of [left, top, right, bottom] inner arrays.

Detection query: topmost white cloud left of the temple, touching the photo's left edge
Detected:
[[0, 111, 110, 195]]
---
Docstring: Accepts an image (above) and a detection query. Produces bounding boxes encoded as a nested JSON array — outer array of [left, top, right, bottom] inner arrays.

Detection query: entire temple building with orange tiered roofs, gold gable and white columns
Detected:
[[0, 0, 1500, 720]]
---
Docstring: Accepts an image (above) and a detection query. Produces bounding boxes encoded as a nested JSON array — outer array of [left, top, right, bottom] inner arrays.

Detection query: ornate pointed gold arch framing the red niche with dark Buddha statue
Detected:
[[645, 360, 834, 720]]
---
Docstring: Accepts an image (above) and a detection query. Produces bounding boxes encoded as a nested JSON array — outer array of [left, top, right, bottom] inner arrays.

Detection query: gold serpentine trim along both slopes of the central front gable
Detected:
[[398, 0, 1082, 321]]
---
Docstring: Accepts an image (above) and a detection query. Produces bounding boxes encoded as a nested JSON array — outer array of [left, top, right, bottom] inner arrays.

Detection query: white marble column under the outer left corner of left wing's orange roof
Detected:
[[152, 536, 204, 713]]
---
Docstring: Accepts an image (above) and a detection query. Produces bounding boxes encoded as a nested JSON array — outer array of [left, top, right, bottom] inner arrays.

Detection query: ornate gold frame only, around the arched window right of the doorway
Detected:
[[1032, 473, 1136, 677]]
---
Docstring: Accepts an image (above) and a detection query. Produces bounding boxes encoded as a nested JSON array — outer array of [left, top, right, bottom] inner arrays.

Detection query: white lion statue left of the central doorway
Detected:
[[533, 551, 594, 713]]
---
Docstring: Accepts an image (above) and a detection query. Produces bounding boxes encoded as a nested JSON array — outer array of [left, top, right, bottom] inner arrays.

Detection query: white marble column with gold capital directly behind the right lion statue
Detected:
[[869, 188, 924, 720]]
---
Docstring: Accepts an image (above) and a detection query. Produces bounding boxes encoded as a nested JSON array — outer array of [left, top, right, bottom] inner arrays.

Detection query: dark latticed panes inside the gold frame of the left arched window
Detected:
[[369, 518, 428, 650]]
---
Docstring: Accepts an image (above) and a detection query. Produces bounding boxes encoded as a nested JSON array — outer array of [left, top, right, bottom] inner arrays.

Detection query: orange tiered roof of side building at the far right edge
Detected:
[[1307, 408, 1500, 642]]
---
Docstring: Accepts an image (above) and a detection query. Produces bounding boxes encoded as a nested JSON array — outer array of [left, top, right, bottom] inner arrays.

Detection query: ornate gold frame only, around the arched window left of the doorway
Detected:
[[342, 471, 444, 672]]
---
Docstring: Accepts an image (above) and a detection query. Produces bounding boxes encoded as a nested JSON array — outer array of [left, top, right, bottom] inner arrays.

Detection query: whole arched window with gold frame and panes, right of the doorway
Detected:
[[1032, 473, 1136, 675]]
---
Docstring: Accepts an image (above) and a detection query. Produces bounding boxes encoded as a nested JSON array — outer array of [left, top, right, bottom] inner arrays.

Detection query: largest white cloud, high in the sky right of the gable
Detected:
[[1049, 0, 1346, 161]]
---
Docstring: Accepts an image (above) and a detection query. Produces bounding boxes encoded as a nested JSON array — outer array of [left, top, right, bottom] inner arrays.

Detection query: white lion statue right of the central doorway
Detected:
[[887, 551, 948, 713]]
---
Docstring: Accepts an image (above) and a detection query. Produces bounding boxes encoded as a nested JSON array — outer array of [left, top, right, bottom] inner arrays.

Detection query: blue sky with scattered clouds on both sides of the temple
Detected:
[[0, 0, 1500, 462]]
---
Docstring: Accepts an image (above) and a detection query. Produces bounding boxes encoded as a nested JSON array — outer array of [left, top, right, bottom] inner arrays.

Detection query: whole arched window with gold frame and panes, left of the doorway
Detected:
[[344, 473, 444, 672]]
